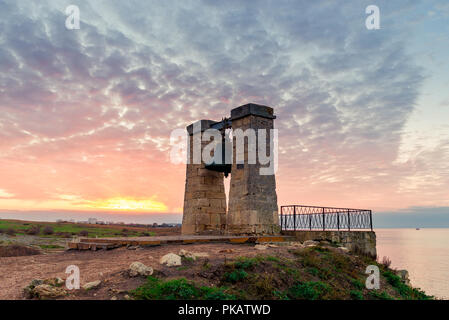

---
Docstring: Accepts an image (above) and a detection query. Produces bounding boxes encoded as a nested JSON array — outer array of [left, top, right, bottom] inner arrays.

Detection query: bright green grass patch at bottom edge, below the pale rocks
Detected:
[[131, 276, 236, 300]]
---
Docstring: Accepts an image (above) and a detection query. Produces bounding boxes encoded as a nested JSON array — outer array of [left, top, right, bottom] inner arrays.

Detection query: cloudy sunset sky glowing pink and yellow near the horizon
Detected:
[[0, 0, 449, 226]]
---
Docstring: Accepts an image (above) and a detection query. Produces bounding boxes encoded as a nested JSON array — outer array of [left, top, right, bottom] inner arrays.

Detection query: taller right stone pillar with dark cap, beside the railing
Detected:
[[226, 104, 280, 234]]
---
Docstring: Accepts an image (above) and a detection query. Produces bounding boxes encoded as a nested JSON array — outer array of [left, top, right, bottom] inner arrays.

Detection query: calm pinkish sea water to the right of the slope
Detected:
[[375, 229, 449, 299]]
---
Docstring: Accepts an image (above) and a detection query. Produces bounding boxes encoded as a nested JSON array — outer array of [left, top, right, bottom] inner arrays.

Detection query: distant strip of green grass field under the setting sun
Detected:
[[0, 220, 155, 238]]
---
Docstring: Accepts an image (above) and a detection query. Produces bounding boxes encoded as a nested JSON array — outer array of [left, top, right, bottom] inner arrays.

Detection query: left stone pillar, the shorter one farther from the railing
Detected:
[[181, 120, 226, 234]]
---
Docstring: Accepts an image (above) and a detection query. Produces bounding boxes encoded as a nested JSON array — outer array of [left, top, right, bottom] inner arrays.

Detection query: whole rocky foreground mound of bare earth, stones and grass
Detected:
[[0, 242, 434, 300]]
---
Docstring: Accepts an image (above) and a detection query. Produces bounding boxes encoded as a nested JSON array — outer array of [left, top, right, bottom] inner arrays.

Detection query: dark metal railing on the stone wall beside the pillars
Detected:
[[280, 205, 373, 231]]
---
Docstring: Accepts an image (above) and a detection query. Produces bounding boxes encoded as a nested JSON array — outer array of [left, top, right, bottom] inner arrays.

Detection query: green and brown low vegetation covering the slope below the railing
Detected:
[[132, 246, 433, 300]]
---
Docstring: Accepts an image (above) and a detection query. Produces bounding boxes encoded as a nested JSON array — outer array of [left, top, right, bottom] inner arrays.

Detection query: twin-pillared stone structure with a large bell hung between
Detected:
[[182, 104, 280, 235]]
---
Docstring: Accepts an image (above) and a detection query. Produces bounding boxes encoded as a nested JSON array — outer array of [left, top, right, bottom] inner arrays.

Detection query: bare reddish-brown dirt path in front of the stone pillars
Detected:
[[0, 243, 274, 300]]
